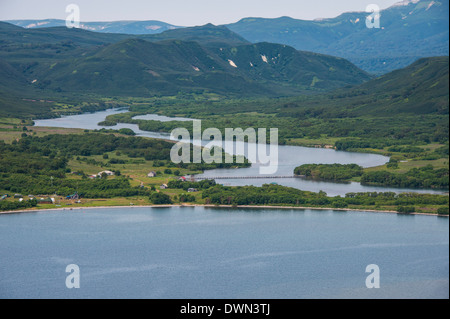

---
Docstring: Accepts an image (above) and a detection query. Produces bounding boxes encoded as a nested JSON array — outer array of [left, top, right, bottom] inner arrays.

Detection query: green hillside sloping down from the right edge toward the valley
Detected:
[[281, 56, 449, 117]]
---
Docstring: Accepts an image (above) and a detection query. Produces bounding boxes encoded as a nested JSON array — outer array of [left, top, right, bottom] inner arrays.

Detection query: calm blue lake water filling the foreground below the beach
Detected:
[[0, 207, 449, 298]]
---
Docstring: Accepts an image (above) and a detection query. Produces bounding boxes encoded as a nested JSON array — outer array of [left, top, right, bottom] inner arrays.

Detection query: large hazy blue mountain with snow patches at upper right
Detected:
[[226, 0, 449, 74]]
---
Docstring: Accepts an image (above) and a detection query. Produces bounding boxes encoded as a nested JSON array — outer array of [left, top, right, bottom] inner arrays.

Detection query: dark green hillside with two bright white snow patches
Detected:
[[217, 42, 370, 90]]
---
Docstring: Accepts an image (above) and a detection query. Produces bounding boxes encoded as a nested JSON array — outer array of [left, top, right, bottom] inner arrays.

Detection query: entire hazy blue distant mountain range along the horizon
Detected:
[[6, 0, 449, 74]]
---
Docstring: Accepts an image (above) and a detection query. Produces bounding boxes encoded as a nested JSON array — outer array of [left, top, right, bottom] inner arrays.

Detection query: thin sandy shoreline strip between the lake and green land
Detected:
[[0, 204, 442, 217]]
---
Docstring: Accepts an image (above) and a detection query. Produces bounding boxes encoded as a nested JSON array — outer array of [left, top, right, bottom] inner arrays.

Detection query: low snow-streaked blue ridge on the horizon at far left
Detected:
[[5, 19, 180, 34]]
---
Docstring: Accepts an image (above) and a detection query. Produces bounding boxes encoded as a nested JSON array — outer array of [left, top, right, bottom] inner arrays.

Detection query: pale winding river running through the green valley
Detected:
[[35, 109, 446, 196]]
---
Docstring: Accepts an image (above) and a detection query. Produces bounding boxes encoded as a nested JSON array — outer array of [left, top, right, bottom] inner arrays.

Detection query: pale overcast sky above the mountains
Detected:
[[0, 0, 399, 26]]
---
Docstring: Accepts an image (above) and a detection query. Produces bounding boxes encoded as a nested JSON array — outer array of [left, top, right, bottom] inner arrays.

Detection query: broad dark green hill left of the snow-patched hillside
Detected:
[[25, 39, 274, 96]]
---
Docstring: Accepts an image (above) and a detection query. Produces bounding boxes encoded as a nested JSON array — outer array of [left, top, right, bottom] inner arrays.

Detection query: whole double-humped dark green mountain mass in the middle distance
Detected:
[[22, 39, 370, 96]]
